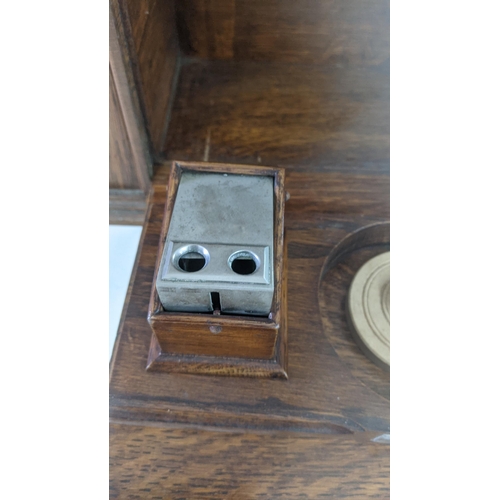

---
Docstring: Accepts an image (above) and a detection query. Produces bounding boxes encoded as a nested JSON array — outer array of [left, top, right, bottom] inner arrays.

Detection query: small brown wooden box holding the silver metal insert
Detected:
[[147, 161, 287, 378]]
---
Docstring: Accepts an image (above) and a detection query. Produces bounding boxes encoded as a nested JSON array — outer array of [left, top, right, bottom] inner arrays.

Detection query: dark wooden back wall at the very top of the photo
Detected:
[[176, 0, 389, 65]]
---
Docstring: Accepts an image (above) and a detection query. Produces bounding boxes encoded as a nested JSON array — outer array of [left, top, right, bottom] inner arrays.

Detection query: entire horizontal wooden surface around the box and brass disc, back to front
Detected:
[[110, 61, 390, 498]]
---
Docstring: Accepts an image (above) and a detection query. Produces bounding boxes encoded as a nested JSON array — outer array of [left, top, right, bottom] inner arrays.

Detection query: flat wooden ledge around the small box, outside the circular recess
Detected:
[[110, 166, 389, 432]]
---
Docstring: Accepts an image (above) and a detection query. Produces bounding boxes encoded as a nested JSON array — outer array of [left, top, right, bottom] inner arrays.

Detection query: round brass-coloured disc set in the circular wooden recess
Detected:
[[347, 252, 390, 371]]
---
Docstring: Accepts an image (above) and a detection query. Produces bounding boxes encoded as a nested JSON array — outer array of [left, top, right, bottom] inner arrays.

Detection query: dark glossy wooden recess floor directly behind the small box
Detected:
[[164, 61, 390, 173]]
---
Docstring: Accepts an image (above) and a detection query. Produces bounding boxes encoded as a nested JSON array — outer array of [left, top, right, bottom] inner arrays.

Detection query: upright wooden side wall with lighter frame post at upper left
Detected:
[[109, 0, 179, 224]]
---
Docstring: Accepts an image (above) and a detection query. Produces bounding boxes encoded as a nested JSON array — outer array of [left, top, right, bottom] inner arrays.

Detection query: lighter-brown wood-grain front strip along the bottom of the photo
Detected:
[[110, 424, 389, 500]]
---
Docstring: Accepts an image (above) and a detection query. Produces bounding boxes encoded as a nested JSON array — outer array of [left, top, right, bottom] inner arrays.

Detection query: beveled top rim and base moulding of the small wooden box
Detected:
[[146, 160, 288, 378]]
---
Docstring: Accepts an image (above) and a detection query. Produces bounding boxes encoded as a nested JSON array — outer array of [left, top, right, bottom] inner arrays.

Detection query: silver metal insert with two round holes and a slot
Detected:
[[156, 172, 274, 316]]
